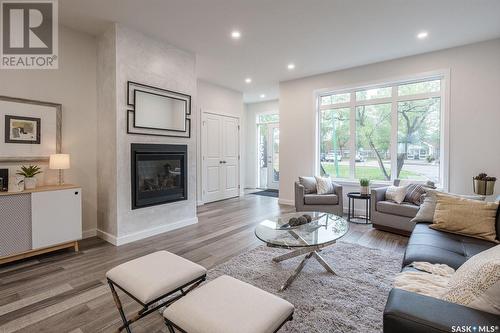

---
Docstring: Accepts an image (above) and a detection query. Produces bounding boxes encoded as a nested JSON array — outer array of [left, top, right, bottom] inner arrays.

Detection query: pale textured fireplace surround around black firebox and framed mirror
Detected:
[[97, 25, 199, 245]]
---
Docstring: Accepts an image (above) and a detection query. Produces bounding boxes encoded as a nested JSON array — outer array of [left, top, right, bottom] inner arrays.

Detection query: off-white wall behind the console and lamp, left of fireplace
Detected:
[[0, 26, 97, 236]]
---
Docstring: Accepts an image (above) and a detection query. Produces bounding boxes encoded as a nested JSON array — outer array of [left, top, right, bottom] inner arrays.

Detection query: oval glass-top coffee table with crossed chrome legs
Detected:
[[255, 212, 349, 291]]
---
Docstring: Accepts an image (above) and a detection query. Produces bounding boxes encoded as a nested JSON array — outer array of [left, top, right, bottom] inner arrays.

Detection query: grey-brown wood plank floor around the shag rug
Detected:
[[0, 194, 407, 333]]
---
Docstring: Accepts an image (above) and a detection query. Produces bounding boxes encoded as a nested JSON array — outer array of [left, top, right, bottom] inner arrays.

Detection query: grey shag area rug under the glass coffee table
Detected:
[[208, 242, 403, 333]]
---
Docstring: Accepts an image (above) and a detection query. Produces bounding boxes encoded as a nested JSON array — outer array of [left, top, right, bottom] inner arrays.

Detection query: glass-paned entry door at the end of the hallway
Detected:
[[258, 123, 280, 190]]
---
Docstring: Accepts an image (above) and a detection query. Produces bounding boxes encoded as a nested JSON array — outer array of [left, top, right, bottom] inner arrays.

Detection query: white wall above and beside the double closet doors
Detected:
[[197, 80, 246, 204]]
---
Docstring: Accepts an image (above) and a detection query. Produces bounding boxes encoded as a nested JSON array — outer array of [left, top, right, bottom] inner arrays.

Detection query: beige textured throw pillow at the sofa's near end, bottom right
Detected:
[[441, 245, 500, 314]]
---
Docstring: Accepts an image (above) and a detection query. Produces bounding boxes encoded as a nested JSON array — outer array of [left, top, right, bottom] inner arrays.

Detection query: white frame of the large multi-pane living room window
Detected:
[[314, 69, 450, 191]]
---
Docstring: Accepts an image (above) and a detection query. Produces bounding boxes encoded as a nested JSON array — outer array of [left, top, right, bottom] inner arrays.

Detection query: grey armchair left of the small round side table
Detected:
[[295, 181, 344, 216]]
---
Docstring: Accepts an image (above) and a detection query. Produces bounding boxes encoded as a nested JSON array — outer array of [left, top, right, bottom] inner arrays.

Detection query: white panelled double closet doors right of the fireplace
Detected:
[[202, 113, 240, 202]]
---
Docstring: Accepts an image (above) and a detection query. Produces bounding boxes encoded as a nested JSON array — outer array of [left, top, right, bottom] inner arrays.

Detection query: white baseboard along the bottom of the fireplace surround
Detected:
[[97, 217, 198, 246]]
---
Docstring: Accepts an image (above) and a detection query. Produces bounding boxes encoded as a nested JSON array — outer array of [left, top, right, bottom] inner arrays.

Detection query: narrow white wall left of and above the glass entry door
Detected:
[[245, 100, 279, 188]]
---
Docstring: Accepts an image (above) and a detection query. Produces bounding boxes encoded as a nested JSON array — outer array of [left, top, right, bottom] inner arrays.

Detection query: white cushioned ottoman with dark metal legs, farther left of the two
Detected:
[[106, 251, 207, 333]]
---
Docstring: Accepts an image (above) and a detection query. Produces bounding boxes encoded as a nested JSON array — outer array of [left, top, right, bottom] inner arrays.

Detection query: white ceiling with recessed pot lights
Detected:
[[59, 0, 500, 102]]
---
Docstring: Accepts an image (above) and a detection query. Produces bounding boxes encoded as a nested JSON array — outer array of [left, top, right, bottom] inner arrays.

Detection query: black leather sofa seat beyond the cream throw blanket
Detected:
[[403, 223, 496, 269]]
